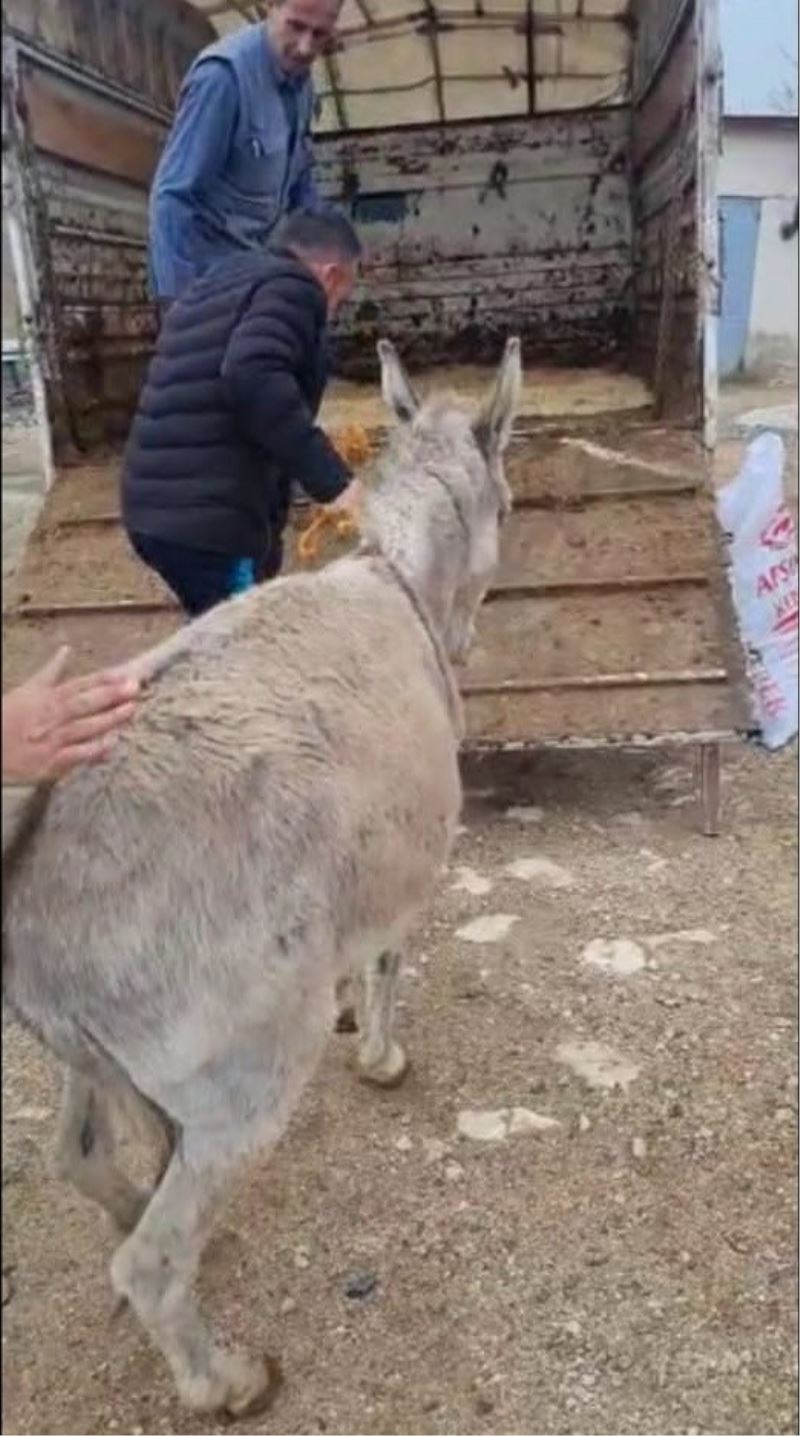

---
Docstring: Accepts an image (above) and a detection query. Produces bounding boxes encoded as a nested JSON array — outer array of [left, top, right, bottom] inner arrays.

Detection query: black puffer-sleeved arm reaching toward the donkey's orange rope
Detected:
[[221, 277, 352, 504]]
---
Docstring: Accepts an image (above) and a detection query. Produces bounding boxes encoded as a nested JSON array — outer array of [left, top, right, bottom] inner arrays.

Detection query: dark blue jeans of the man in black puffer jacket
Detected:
[[129, 534, 282, 617]]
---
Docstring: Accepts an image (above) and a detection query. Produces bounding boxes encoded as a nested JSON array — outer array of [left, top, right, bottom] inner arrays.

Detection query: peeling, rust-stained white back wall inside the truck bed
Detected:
[[317, 111, 632, 378]]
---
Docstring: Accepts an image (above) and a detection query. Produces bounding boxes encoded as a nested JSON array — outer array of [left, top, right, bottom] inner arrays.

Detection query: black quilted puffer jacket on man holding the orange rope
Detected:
[[122, 251, 350, 559]]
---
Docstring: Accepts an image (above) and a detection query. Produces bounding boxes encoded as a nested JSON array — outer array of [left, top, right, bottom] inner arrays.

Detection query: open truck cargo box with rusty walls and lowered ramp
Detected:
[[4, 0, 750, 821]]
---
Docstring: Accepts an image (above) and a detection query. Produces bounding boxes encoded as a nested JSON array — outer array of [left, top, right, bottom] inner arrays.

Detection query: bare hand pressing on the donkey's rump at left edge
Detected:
[[3, 648, 139, 783]]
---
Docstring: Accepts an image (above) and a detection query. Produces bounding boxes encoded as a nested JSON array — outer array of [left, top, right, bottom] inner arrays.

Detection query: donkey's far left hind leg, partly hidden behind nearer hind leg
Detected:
[[56, 1068, 155, 1234]]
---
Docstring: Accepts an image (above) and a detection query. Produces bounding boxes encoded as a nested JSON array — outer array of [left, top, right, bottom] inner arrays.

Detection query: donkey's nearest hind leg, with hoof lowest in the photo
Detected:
[[111, 1005, 333, 1416]]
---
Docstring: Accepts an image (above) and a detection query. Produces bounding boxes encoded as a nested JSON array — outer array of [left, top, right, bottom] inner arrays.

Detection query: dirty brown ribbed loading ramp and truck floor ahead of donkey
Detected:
[[4, 370, 748, 831]]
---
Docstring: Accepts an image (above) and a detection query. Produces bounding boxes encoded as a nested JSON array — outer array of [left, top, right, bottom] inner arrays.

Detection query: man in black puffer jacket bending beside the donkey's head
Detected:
[[122, 213, 361, 616]]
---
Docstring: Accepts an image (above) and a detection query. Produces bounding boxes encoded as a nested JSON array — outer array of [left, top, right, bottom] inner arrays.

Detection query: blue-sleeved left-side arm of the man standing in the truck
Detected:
[[151, 59, 238, 300]]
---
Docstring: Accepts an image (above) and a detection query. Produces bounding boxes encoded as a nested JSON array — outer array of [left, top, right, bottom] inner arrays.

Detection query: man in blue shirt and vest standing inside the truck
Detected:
[[149, 0, 342, 306]]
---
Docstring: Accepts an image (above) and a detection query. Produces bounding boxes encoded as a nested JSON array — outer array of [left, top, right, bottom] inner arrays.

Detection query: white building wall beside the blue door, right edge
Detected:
[[718, 119, 797, 372]]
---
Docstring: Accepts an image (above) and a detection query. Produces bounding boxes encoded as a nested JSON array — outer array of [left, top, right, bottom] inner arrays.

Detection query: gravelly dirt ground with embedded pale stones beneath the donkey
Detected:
[[3, 373, 799, 1436]]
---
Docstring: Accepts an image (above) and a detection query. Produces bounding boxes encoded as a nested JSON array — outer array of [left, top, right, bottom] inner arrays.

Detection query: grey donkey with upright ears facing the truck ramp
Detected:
[[3, 340, 521, 1416]]
